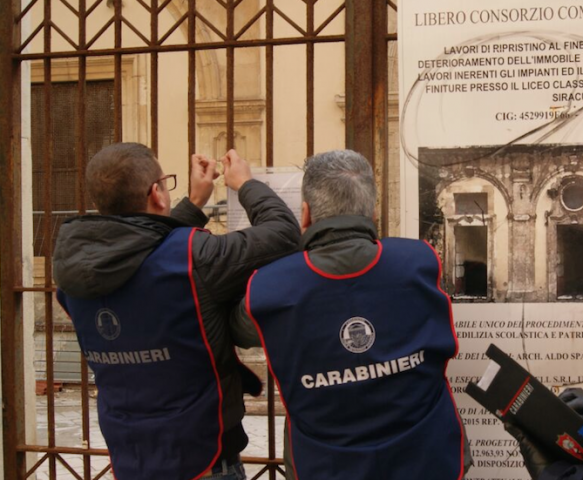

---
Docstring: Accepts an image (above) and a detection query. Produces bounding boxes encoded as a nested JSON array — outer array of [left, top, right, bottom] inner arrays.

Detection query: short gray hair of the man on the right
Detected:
[[302, 150, 376, 223]]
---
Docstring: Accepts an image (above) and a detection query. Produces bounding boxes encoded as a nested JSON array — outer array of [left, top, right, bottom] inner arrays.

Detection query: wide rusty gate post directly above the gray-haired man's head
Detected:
[[345, 0, 379, 162]]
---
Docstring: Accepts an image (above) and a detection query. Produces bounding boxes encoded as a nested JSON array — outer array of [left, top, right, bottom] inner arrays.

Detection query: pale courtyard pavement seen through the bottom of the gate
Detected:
[[30, 388, 284, 480]]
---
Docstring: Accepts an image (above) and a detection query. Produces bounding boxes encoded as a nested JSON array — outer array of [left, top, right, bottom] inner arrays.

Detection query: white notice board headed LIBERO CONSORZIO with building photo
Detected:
[[399, 0, 583, 480]]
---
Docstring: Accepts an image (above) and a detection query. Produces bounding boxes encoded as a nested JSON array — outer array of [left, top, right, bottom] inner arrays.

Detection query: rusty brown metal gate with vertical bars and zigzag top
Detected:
[[0, 0, 397, 480]]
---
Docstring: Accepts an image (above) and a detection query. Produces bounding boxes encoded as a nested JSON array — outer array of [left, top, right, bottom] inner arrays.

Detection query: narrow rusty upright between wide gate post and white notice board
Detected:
[[371, 2, 389, 237]]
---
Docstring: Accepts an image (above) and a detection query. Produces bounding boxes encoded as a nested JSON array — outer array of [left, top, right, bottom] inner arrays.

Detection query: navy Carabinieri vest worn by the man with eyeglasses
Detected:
[[58, 228, 223, 480]]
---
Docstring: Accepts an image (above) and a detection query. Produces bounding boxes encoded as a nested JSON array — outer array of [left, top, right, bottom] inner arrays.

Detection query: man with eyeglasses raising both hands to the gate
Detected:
[[54, 143, 299, 480]]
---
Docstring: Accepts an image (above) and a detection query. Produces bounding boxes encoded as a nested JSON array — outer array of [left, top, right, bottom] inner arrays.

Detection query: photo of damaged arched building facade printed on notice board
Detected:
[[418, 144, 583, 302]]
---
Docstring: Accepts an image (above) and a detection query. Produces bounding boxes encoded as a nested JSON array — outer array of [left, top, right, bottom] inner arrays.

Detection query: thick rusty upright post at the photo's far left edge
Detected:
[[0, 0, 26, 479]]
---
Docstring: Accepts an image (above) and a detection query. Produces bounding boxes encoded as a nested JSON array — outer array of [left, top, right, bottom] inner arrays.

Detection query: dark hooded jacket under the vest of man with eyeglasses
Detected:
[[53, 180, 300, 457]]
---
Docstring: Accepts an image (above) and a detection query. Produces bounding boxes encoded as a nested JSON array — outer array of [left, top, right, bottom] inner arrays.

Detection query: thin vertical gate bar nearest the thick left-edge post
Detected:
[[43, 0, 57, 480]]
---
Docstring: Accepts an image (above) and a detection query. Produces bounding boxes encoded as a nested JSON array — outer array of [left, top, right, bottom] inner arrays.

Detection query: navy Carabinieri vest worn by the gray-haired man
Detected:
[[247, 238, 463, 480]]
